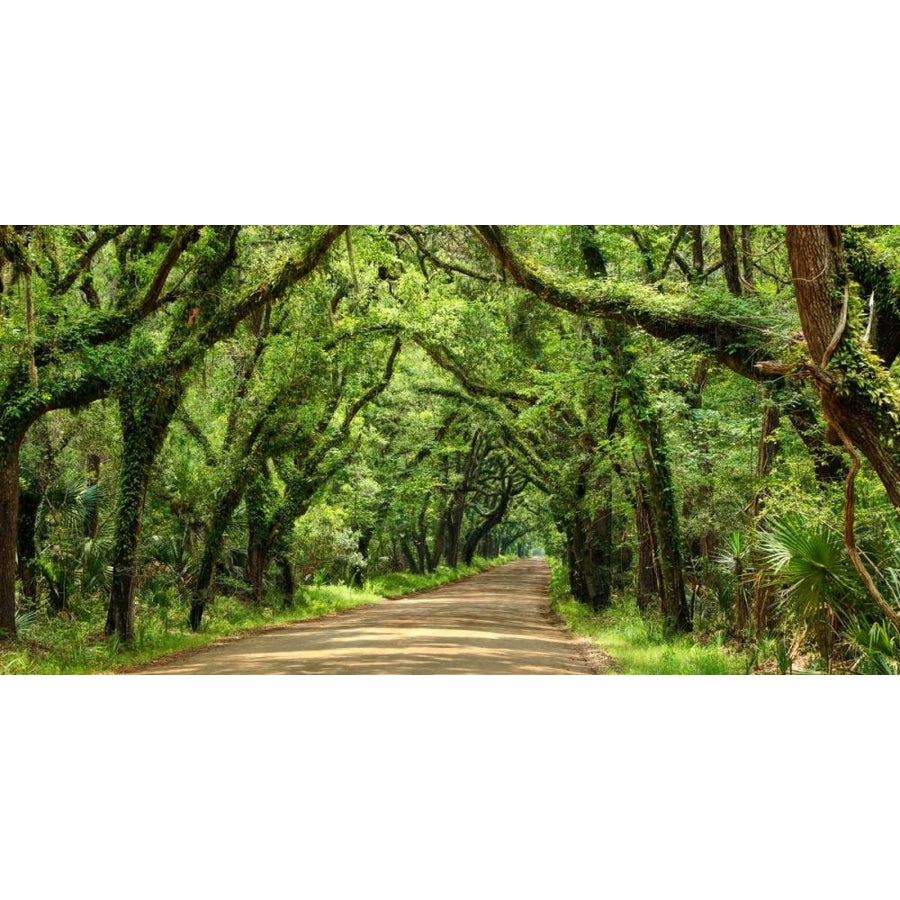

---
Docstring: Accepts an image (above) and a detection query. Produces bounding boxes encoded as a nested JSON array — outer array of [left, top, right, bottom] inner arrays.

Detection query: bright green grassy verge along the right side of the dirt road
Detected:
[[549, 559, 748, 675]]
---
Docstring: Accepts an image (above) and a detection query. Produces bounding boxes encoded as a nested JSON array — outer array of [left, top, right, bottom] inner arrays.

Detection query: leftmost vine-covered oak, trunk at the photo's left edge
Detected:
[[0, 226, 200, 634]]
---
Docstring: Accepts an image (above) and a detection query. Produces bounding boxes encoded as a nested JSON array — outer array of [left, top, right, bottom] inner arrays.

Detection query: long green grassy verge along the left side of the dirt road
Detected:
[[0, 558, 508, 675]]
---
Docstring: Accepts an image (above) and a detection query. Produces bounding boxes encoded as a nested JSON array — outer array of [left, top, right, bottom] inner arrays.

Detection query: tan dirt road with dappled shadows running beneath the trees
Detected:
[[144, 559, 592, 675]]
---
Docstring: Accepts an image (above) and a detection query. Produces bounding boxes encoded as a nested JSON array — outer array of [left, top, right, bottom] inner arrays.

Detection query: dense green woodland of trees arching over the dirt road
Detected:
[[0, 225, 900, 673]]
